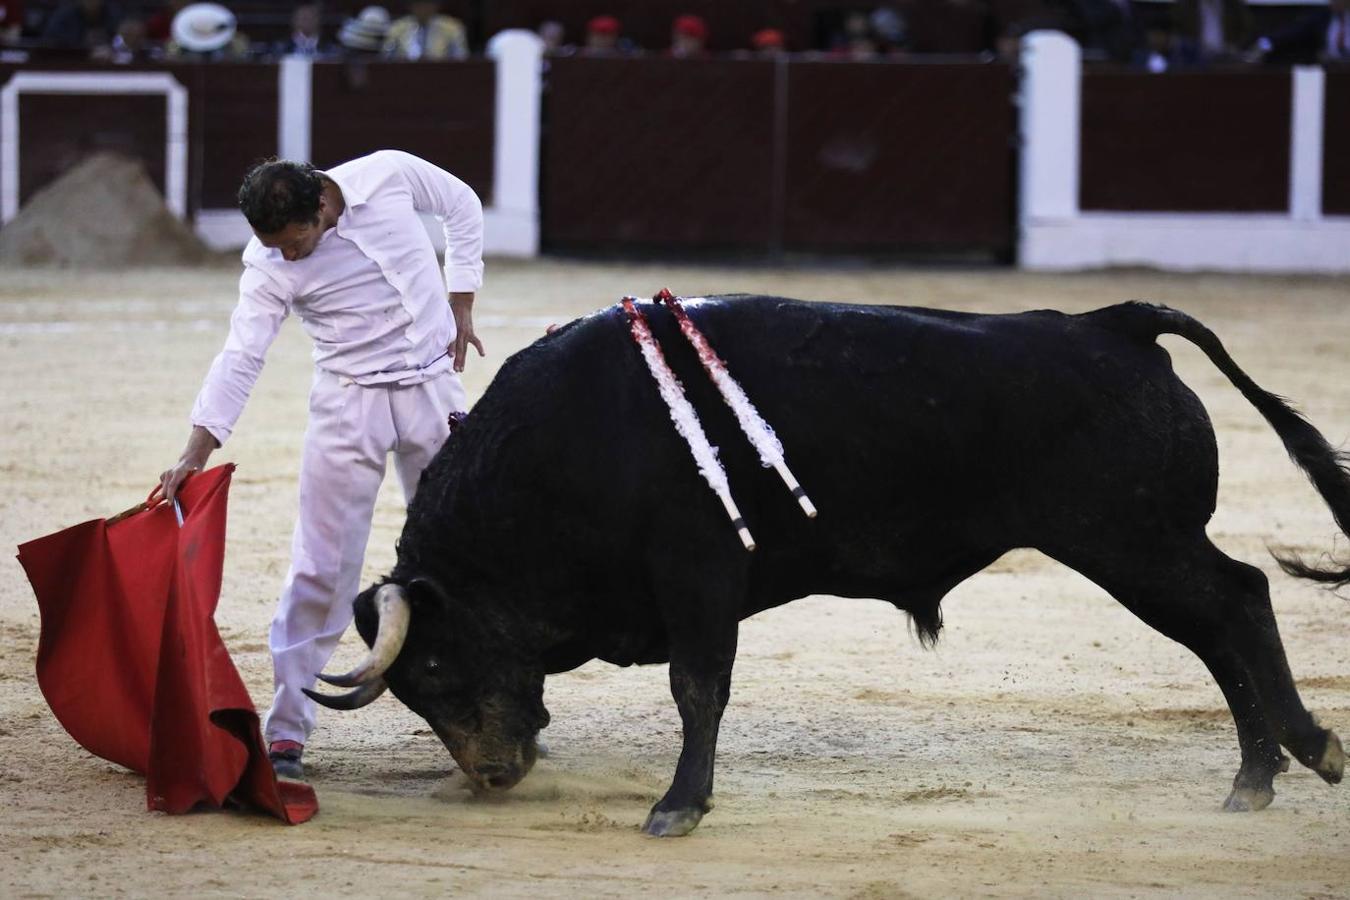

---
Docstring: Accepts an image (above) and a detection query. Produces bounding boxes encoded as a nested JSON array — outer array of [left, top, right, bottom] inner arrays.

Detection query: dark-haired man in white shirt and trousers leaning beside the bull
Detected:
[[159, 150, 483, 779]]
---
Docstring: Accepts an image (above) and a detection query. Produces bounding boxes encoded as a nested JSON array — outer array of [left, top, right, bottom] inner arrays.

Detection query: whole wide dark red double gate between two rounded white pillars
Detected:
[[543, 58, 1015, 252]]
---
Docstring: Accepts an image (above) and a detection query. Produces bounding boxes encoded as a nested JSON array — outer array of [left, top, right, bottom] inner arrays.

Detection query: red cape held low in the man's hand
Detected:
[[19, 464, 319, 824]]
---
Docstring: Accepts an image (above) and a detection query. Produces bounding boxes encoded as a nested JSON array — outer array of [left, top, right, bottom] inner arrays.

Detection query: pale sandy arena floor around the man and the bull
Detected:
[[0, 262, 1350, 897]]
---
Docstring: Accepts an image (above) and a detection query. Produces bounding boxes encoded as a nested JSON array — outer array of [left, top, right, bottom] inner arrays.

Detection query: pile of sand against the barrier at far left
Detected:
[[0, 154, 211, 269]]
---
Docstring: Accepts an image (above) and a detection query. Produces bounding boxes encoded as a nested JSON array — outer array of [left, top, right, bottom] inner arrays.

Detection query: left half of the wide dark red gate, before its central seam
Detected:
[[543, 59, 774, 247]]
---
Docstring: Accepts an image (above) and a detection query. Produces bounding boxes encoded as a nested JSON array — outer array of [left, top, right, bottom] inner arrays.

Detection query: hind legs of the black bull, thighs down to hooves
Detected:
[[1052, 536, 1345, 811]]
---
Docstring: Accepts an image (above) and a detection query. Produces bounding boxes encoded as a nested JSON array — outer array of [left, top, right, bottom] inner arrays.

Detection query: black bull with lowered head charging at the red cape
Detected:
[[309, 297, 1350, 834]]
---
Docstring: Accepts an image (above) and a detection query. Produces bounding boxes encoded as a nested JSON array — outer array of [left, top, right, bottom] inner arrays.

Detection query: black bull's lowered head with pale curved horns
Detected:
[[305, 579, 548, 791]]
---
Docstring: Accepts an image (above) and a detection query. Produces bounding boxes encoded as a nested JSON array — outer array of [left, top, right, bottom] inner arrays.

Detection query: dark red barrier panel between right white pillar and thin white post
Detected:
[[1080, 69, 1291, 212]]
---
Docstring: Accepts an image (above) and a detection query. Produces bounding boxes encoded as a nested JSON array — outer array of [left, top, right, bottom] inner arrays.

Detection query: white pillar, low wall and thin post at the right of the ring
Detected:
[[1018, 31, 1350, 273]]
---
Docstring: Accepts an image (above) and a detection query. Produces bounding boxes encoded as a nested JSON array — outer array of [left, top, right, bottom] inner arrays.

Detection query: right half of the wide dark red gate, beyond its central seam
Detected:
[[784, 62, 1017, 250]]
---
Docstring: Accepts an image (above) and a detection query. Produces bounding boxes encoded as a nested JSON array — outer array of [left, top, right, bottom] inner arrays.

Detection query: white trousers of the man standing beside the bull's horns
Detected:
[[263, 370, 467, 743]]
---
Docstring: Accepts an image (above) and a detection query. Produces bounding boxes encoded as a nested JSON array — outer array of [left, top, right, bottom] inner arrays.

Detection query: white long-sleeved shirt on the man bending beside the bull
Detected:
[[192, 150, 483, 444]]
